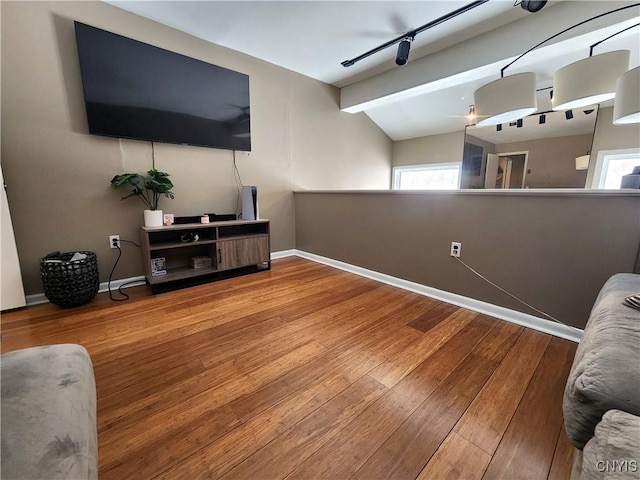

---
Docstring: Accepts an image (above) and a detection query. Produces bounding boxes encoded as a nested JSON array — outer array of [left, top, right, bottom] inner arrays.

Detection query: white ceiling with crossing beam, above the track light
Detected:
[[108, 0, 640, 140]]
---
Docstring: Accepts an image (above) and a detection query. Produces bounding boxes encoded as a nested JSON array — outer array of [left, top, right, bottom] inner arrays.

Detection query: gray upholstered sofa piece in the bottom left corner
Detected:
[[0, 344, 98, 480]]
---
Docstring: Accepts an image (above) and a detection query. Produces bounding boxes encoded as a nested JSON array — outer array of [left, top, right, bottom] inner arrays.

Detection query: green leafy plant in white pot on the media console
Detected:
[[111, 168, 175, 227]]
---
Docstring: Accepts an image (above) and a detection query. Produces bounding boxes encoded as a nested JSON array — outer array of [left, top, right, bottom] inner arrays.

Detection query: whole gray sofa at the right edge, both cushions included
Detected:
[[563, 273, 640, 480]]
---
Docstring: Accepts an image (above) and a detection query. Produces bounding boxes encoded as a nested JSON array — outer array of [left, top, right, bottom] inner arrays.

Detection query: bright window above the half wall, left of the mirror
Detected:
[[393, 162, 462, 190]]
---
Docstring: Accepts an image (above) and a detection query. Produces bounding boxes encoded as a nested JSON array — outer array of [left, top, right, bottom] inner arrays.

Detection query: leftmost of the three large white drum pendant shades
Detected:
[[473, 72, 538, 127]]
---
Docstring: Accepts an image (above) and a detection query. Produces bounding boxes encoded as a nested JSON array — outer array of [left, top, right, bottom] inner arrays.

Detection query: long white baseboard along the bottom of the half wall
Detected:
[[295, 250, 582, 343]]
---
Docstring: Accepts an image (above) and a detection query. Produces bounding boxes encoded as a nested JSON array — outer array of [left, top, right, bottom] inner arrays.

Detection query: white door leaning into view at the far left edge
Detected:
[[0, 167, 27, 310]]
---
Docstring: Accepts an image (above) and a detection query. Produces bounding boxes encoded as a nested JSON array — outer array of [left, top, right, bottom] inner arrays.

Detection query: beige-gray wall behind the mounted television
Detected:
[[0, 1, 392, 294]]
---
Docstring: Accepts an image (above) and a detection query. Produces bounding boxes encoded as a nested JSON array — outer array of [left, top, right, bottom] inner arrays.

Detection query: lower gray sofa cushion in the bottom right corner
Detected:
[[580, 410, 640, 480]]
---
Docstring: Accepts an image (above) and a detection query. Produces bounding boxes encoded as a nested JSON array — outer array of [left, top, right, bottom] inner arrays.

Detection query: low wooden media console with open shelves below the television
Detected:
[[140, 220, 271, 294]]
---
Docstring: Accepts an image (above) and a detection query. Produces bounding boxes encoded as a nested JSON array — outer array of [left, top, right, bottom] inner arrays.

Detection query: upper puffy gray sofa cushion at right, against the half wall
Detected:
[[563, 273, 640, 449]]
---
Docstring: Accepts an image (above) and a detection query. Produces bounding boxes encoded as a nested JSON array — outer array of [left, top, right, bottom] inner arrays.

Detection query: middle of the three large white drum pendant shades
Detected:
[[551, 50, 629, 110]]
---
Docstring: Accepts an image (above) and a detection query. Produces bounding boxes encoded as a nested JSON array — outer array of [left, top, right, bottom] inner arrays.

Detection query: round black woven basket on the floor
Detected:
[[40, 252, 100, 308]]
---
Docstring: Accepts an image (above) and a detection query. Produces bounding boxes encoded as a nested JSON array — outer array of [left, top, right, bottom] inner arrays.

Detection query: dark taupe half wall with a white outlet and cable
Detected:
[[294, 191, 640, 327]]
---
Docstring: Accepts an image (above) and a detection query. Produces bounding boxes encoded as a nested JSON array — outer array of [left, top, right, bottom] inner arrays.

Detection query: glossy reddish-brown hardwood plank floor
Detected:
[[1, 257, 576, 480]]
